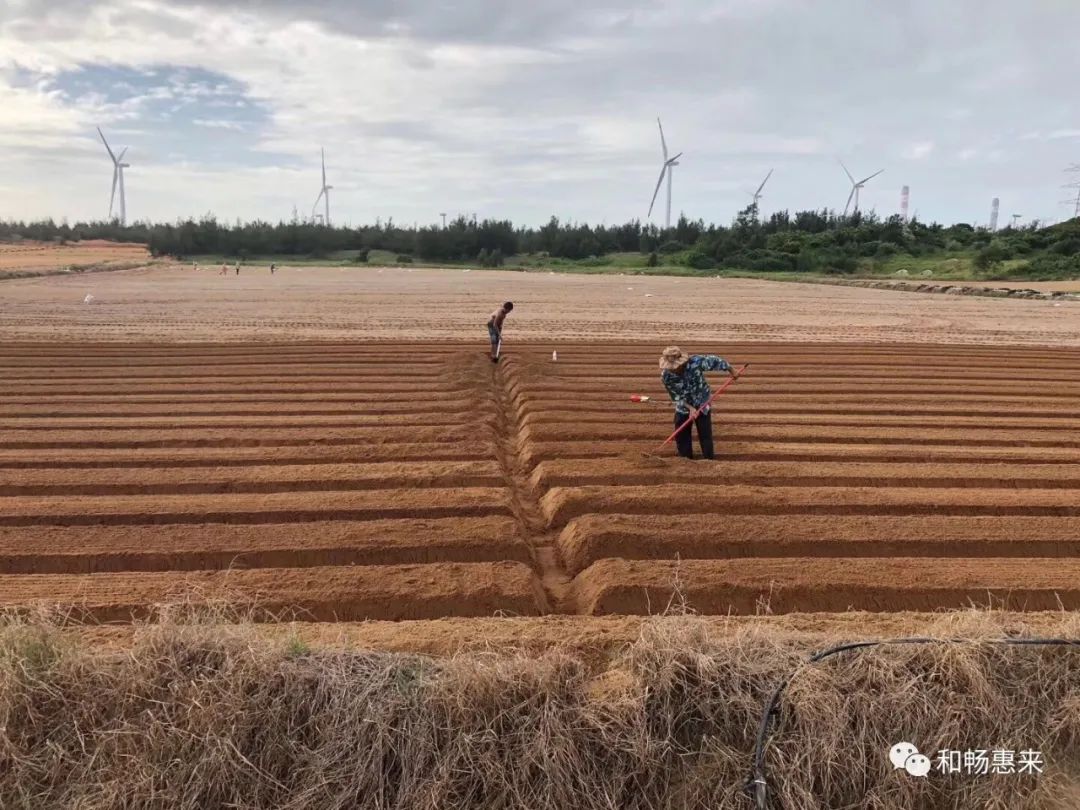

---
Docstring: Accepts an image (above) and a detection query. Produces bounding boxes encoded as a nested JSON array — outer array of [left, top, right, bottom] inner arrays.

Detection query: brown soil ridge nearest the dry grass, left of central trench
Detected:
[[0, 562, 543, 622]]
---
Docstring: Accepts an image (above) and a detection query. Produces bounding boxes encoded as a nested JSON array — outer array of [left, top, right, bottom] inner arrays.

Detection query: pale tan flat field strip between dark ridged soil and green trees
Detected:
[[0, 266, 1080, 345]]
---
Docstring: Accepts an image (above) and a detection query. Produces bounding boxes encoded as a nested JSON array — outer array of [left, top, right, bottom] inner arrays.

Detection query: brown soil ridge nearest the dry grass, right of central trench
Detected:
[[573, 557, 1080, 613]]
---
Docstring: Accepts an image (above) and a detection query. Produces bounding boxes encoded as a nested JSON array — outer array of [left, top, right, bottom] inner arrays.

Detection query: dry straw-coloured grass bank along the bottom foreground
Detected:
[[0, 611, 1080, 810]]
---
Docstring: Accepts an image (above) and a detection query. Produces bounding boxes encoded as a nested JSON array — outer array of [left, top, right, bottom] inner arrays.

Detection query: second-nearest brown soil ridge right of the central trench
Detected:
[[558, 514, 1080, 575]]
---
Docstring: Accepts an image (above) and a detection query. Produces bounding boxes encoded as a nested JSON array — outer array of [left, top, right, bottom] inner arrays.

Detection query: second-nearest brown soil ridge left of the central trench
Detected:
[[0, 516, 531, 573]]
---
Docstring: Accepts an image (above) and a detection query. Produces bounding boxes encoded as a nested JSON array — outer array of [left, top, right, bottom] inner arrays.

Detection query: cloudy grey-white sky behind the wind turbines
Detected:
[[0, 0, 1080, 224]]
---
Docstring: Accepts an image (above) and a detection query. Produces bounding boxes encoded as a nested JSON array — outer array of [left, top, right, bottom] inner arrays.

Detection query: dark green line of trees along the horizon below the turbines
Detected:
[[0, 206, 1080, 273]]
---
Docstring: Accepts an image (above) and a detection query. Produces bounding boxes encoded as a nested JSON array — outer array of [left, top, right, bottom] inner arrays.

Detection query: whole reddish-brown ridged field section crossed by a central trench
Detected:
[[0, 342, 1080, 621]]
